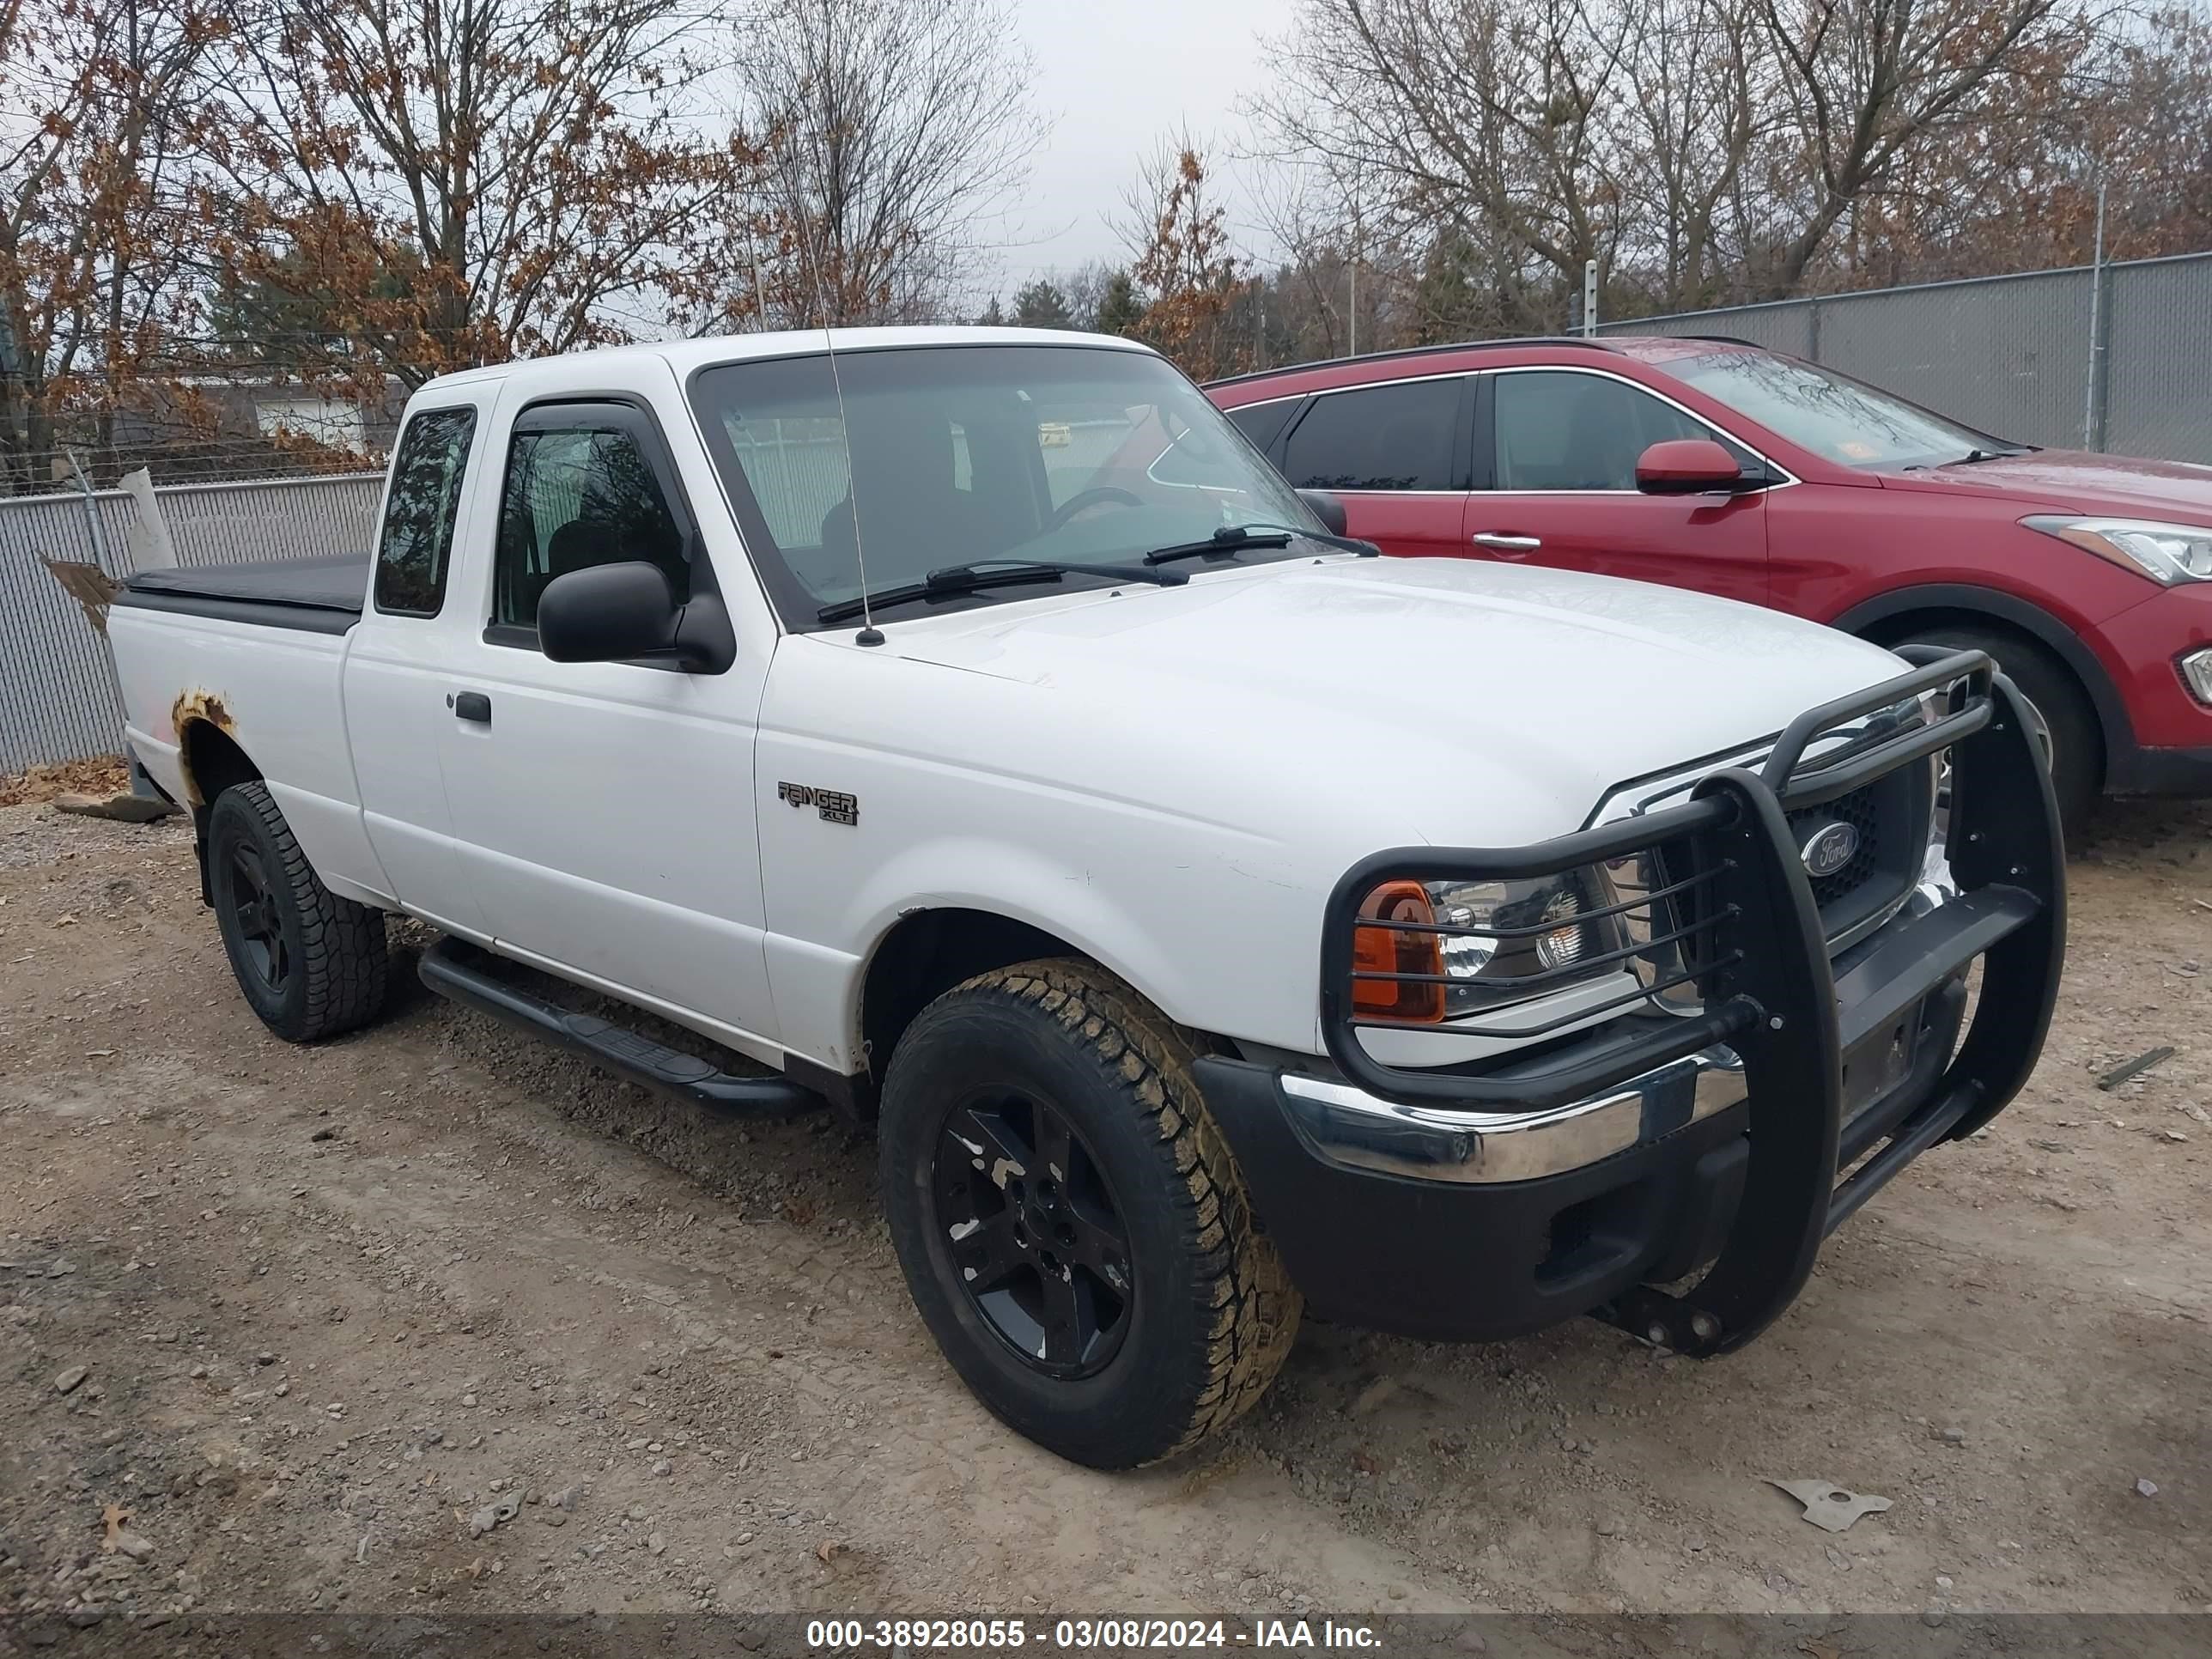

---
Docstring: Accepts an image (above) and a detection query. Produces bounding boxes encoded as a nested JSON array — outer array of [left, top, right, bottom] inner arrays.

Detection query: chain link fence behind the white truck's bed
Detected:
[[0, 473, 385, 772]]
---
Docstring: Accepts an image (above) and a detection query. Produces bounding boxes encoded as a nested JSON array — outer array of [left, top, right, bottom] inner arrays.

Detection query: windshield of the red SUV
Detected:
[[1659, 349, 2008, 467]]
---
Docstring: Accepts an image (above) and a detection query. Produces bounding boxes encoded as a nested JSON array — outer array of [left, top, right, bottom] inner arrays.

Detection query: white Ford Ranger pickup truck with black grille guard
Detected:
[[111, 330, 2063, 1467]]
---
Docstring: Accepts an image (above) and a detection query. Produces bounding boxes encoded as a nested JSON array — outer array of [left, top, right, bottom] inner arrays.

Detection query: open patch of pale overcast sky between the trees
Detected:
[[1005, 0, 1291, 299]]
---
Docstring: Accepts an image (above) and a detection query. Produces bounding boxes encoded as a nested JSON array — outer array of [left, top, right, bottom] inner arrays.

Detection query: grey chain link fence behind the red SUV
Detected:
[[1597, 254, 2212, 462]]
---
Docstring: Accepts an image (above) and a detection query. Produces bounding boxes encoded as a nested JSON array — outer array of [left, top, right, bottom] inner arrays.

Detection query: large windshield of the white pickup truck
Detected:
[[692, 345, 1321, 629]]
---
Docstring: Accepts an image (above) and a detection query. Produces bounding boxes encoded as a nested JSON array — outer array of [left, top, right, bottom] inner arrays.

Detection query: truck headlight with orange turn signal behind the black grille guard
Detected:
[[1352, 869, 1624, 1024]]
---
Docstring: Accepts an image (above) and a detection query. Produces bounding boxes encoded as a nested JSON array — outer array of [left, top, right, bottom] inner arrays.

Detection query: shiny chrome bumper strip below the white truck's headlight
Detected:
[[1281, 1044, 1743, 1183]]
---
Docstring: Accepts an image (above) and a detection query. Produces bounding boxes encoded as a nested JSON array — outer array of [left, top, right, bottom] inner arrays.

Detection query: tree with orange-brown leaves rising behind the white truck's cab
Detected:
[[204, 0, 759, 385]]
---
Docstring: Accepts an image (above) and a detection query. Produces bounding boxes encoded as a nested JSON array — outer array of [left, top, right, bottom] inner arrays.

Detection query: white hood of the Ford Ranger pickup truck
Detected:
[[891, 557, 1905, 845]]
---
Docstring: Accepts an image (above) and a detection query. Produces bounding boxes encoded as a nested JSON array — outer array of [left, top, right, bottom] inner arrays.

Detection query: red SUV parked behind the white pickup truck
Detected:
[[1207, 337, 2212, 823]]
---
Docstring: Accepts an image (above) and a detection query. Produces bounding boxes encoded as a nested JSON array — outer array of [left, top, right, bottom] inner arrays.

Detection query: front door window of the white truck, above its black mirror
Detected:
[[493, 411, 690, 629]]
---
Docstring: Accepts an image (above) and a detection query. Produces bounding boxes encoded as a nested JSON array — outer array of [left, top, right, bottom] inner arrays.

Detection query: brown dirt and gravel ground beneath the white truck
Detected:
[[0, 805, 2212, 1627]]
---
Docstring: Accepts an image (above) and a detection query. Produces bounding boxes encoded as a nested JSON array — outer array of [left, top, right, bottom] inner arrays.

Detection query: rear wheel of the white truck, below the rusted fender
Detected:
[[208, 783, 387, 1042]]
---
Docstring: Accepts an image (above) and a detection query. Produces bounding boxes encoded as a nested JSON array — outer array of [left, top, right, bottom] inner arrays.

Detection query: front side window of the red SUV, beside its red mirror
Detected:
[[1491, 369, 1759, 491]]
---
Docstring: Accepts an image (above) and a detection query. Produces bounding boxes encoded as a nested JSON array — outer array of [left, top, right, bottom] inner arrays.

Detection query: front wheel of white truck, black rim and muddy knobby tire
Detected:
[[878, 957, 1301, 1468]]
